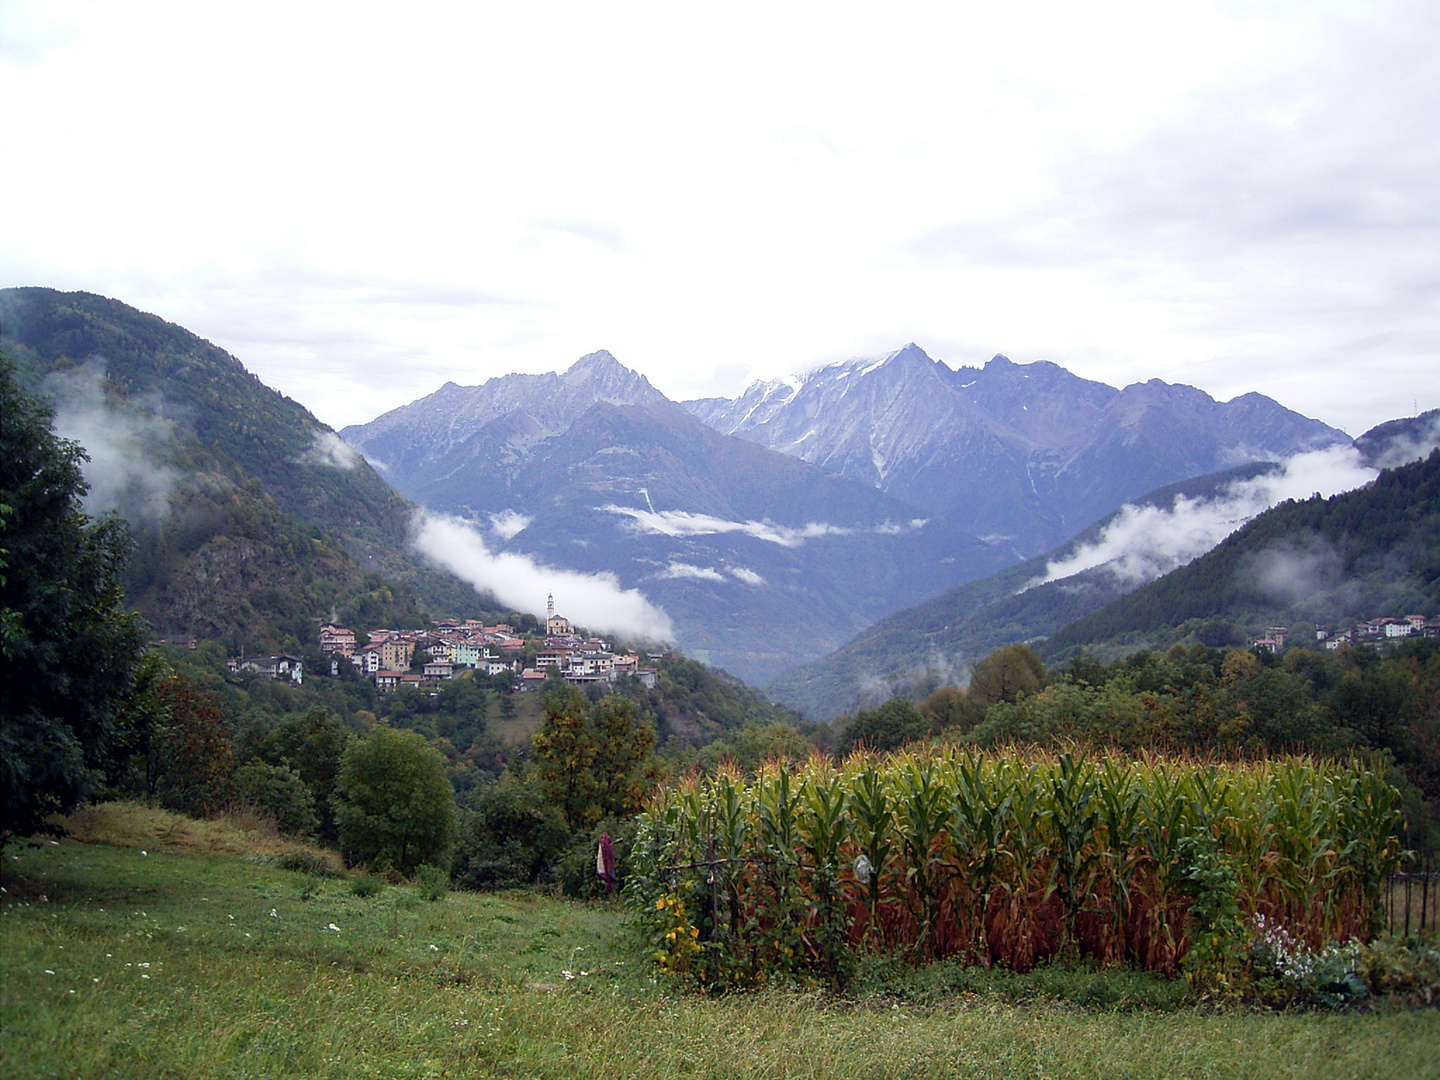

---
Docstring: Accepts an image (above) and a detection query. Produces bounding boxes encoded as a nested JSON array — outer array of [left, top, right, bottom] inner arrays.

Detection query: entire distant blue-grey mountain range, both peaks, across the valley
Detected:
[[341, 344, 1349, 683]]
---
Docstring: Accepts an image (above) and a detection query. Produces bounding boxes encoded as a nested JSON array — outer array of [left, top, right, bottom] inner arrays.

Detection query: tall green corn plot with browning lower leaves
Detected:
[[626, 747, 1401, 986]]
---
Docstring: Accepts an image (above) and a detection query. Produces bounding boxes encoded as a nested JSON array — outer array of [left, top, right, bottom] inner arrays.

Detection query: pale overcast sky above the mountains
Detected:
[[0, 0, 1440, 433]]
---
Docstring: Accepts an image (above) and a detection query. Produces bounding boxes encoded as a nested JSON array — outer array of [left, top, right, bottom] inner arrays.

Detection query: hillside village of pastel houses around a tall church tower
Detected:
[[320, 596, 657, 690]]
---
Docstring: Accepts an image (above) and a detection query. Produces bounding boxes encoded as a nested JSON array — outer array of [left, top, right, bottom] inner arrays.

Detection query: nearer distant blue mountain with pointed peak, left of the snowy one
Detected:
[[341, 353, 1009, 683]]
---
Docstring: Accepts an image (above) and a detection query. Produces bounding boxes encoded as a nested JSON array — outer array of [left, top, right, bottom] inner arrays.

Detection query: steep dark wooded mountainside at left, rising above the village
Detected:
[[0, 288, 498, 648]]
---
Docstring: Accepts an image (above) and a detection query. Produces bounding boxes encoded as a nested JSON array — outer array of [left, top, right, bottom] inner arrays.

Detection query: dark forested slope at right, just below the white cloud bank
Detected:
[[1041, 451, 1440, 661]]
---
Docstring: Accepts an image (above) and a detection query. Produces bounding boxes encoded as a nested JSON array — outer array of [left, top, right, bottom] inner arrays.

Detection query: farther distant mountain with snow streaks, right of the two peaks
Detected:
[[685, 344, 1349, 557]]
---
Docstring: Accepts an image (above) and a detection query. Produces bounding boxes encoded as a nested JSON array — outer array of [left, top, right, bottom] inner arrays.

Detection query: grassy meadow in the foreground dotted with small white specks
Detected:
[[0, 812, 1440, 1079]]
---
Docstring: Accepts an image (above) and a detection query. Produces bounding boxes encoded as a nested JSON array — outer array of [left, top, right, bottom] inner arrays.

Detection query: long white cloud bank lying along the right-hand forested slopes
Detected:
[[1025, 446, 1380, 590]]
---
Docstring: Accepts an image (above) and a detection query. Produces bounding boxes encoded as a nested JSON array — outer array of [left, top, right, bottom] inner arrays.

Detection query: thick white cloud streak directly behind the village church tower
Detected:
[[412, 510, 675, 641]]
